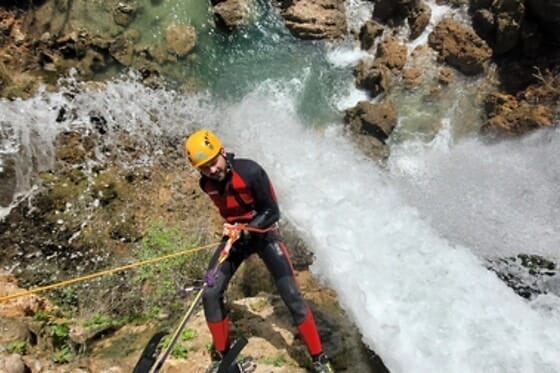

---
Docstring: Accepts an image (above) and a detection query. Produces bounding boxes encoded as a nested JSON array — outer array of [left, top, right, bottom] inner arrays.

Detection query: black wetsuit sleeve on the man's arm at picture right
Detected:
[[249, 166, 280, 229]]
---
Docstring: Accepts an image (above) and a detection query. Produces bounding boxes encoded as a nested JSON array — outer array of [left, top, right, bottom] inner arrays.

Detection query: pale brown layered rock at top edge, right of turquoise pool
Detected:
[[280, 0, 347, 39]]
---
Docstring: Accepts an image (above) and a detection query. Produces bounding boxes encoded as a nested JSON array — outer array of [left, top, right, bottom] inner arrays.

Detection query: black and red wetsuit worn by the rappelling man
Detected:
[[200, 153, 322, 356]]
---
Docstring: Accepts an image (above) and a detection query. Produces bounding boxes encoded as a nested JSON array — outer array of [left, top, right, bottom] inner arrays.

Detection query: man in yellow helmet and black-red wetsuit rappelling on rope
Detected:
[[185, 129, 333, 373]]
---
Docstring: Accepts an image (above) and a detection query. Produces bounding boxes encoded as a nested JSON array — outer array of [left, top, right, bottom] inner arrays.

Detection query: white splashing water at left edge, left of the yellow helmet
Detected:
[[0, 75, 214, 219]]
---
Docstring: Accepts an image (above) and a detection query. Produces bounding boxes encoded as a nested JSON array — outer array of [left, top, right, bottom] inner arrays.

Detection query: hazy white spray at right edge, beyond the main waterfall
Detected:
[[389, 129, 560, 259]]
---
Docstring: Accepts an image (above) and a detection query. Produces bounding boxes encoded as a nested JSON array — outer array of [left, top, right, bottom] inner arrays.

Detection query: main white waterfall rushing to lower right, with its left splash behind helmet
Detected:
[[2, 83, 560, 373]]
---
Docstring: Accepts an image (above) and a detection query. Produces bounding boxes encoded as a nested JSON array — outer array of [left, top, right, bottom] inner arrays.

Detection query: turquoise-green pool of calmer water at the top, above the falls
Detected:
[[132, 0, 353, 125]]
